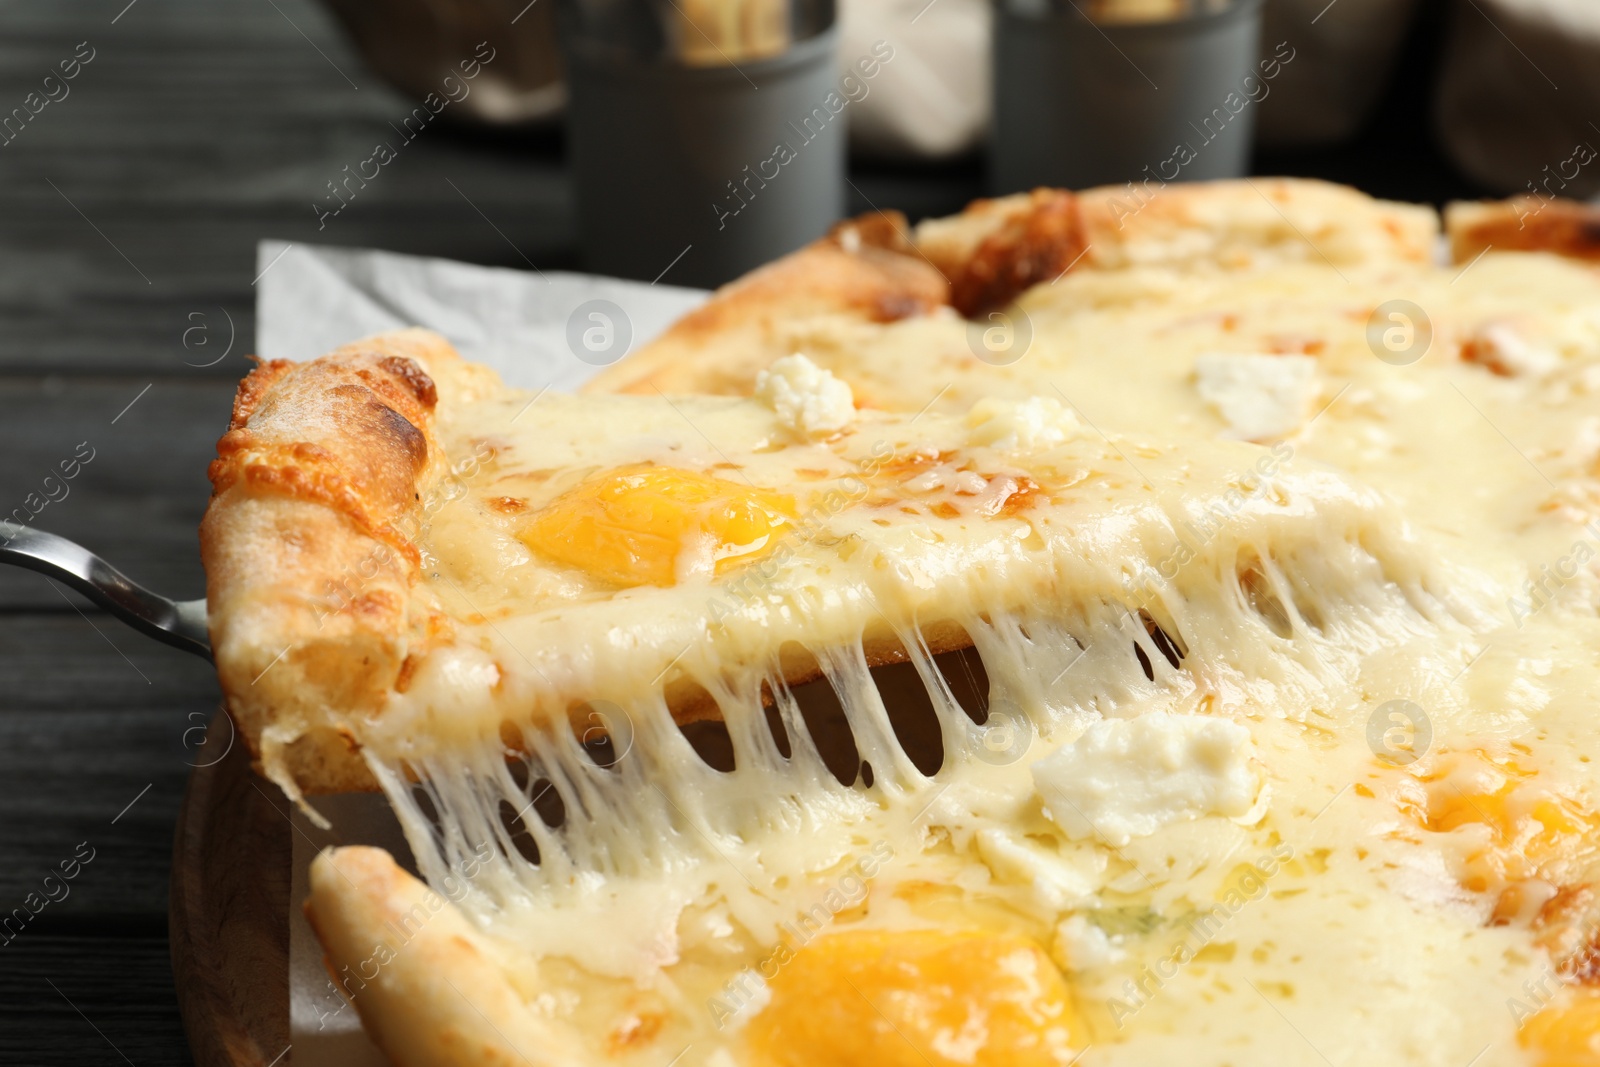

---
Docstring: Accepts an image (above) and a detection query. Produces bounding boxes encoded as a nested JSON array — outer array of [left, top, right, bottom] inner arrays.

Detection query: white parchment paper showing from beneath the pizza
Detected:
[[256, 242, 706, 1067]]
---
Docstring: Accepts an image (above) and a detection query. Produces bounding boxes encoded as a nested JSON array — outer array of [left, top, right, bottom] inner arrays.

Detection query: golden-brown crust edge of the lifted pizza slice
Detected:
[[200, 330, 459, 797]]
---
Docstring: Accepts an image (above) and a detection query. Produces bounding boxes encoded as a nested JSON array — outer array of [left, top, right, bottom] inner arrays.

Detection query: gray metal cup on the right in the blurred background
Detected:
[[990, 0, 1264, 194]]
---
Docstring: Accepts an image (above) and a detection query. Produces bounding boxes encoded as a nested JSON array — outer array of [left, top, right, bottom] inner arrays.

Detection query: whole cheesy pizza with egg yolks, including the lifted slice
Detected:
[[202, 179, 1600, 1067]]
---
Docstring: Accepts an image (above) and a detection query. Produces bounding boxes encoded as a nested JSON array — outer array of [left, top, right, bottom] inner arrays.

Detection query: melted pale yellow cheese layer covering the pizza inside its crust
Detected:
[[302, 247, 1600, 1067]]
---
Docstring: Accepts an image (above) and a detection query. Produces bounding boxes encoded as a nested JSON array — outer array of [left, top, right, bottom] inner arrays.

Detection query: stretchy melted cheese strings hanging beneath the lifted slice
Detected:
[[366, 526, 1470, 925]]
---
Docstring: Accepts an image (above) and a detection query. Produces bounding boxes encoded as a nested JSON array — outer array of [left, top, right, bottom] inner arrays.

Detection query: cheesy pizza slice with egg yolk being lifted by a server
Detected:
[[202, 331, 1465, 809]]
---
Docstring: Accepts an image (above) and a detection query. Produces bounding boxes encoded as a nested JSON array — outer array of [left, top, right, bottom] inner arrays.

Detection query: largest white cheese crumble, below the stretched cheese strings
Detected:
[[1034, 712, 1266, 846]]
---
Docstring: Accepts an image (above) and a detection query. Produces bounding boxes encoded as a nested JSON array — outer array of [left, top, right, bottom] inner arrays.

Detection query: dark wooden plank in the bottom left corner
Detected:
[[0, 934, 194, 1067]]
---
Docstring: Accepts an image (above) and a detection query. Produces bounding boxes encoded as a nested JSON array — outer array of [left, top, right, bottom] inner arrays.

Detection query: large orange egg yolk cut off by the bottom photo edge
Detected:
[[749, 931, 1086, 1067]]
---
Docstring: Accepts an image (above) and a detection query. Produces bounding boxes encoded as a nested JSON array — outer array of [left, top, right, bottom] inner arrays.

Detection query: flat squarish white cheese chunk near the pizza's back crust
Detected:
[[1195, 352, 1320, 442]]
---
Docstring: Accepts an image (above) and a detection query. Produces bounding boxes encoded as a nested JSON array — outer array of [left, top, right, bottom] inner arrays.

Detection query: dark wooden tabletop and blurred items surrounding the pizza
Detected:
[[0, 0, 1600, 1067]]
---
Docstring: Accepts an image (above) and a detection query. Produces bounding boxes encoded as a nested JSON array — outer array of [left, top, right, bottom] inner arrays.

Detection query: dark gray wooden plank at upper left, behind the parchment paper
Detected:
[[0, 0, 574, 378]]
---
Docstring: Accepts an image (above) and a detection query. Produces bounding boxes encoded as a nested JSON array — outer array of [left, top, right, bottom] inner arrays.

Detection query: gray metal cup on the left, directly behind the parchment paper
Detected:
[[566, 27, 846, 286]]
